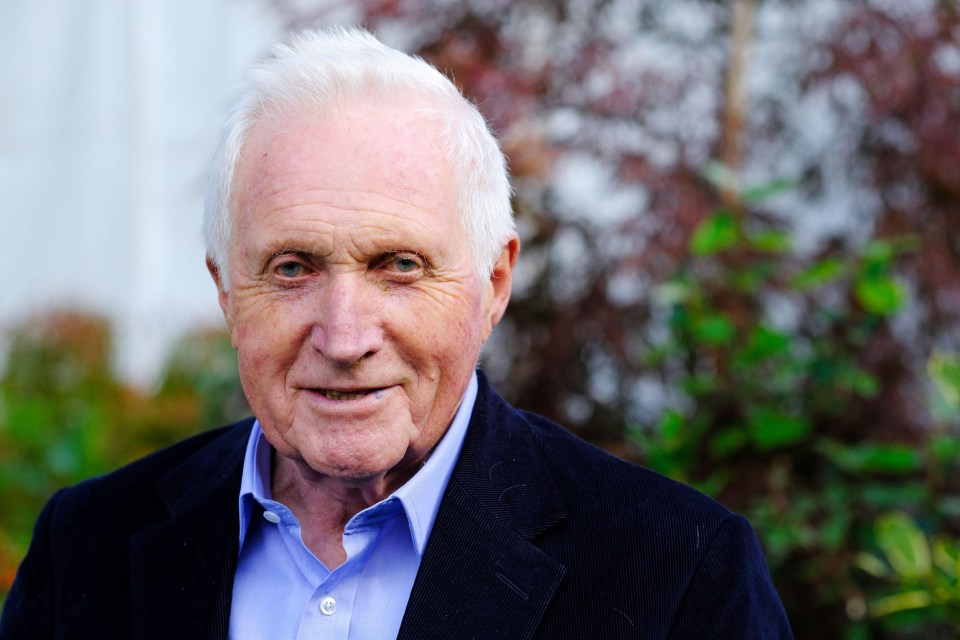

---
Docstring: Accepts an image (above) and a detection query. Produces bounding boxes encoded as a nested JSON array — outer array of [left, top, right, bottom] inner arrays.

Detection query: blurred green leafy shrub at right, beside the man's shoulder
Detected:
[[630, 174, 960, 638]]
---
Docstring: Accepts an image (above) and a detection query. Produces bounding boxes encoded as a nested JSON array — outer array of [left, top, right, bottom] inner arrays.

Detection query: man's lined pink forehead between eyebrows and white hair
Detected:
[[232, 99, 457, 224]]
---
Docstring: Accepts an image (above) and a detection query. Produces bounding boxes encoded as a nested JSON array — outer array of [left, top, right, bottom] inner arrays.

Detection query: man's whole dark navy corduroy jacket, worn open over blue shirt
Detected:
[[0, 374, 791, 640]]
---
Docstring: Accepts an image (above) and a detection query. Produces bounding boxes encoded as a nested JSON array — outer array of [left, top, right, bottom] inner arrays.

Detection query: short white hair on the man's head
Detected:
[[203, 27, 514, 290]]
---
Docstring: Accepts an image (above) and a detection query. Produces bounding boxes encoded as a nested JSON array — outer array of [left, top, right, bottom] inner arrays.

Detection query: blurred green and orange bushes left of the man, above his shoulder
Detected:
[[0, 312, 247, 600]]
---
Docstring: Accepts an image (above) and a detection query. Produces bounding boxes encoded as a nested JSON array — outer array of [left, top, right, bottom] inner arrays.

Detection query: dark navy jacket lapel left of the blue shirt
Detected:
[[130, 421, 251, 639]]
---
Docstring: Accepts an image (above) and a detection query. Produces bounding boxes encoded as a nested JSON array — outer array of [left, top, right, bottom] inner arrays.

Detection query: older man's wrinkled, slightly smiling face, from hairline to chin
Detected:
[[215, 103, 518, 481]]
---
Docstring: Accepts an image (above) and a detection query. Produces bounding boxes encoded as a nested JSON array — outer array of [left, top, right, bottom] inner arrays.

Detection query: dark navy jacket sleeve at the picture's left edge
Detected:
[[0, 492, 61, 640]]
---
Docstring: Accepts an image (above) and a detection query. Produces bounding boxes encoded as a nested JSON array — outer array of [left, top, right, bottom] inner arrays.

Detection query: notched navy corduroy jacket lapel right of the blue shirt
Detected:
[[399, 374, 565, 640]]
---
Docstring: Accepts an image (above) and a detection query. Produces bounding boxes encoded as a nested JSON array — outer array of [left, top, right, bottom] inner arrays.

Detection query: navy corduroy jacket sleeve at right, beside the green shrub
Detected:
[[669, 515, 793, 640]]
